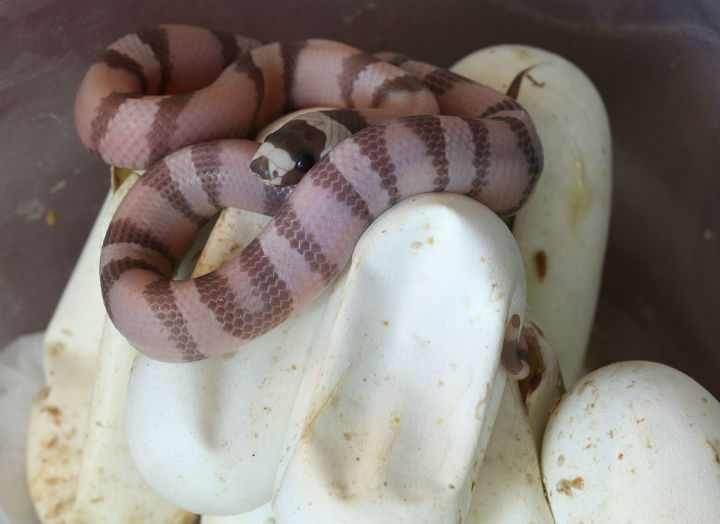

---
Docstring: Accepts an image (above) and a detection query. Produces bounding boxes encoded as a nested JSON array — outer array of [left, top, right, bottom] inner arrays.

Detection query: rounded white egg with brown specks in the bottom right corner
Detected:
[[541, 361, 720, 522]]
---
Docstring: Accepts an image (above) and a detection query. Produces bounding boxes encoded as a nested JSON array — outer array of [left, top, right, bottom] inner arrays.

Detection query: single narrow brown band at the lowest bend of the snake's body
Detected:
[[143, 280, 206, 362]]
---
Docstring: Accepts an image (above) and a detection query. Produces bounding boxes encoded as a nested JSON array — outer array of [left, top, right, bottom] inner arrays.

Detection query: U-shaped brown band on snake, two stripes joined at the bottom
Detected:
[[195, 238, 292, 340]]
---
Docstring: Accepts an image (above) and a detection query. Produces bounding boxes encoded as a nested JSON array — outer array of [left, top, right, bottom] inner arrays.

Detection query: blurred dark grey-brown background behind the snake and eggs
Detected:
[[0, 0, 720, 397]]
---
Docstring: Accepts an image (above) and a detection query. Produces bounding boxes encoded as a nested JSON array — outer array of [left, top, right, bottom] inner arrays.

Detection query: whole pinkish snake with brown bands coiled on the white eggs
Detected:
[[75, 26, 543, 371]]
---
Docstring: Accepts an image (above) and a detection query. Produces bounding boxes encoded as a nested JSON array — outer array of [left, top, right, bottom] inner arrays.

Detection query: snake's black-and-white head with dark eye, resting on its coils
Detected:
[[250, 117, 327, 186]]
